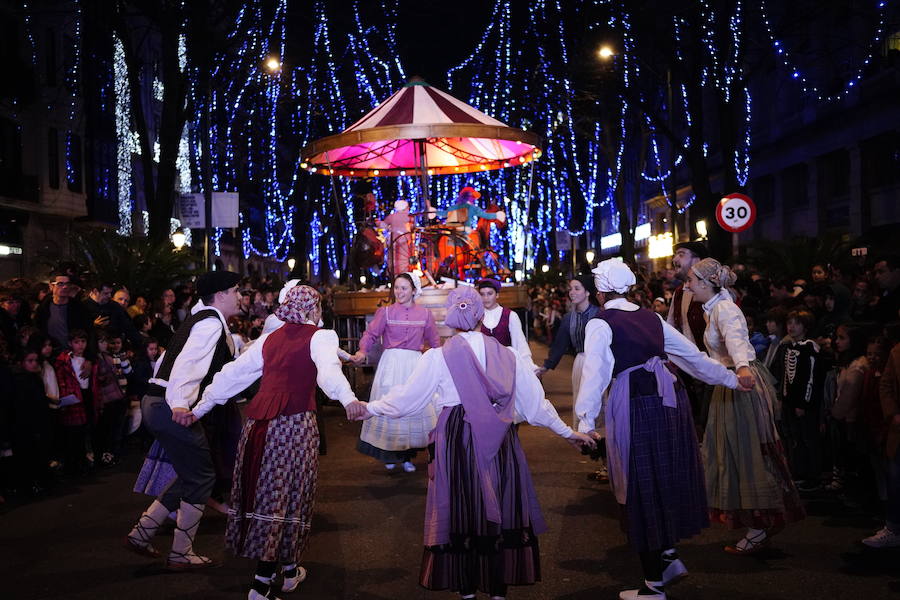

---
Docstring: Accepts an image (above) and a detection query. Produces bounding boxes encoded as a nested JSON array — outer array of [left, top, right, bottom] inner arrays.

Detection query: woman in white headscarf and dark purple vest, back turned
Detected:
[[575, 259, 738, 600]]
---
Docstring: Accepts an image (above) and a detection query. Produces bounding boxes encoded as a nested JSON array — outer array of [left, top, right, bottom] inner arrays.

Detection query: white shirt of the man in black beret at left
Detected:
[[150, 302, 231, 409]]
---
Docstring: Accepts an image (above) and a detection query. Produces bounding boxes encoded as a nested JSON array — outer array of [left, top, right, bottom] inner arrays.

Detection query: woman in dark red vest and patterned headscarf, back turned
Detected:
[[192, 285, 361, 600]]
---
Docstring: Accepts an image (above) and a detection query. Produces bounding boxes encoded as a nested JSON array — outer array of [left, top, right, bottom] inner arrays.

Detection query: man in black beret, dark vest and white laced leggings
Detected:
[[125, 271, 240, 571]]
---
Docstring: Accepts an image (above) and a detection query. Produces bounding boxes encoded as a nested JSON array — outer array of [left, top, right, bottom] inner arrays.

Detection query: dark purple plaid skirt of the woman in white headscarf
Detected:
[[623, 383, 709, 552]]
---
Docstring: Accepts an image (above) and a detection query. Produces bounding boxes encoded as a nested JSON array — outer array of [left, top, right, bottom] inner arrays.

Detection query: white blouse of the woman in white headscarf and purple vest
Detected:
[[575, 298, 738, 433]]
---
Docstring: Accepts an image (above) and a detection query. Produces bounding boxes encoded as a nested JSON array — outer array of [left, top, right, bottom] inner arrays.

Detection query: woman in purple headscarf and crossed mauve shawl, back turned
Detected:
[[356, 287, 593, 598]]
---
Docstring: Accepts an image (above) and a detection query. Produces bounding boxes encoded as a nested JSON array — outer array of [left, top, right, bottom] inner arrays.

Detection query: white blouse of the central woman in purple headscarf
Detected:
[[368, 331, 575, 438]]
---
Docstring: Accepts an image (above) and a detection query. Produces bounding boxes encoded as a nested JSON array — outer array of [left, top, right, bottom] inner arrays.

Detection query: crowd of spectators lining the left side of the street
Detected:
[[0, 263, 334, 502]]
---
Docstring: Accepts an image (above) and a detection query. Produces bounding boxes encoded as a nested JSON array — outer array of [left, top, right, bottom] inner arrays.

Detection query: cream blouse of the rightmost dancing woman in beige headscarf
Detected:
[[703, 290, 756, 369]]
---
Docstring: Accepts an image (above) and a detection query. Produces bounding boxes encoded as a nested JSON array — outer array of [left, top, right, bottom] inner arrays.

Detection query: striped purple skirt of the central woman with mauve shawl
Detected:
[[420, 405, 543, 596]]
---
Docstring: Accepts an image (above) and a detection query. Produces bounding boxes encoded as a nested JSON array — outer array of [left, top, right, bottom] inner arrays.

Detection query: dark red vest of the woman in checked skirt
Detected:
[[247, 323, 319, 420]]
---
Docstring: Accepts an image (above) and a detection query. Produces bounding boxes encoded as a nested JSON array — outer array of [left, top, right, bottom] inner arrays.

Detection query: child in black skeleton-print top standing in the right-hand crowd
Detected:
[[775, 310, 822, 492]]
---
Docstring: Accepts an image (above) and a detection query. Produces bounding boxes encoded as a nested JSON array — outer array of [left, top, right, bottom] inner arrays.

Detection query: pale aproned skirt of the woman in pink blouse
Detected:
[[358, 348, 437, 458]]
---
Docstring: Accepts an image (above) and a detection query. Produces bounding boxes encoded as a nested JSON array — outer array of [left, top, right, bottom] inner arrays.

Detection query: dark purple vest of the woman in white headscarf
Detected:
[[597, 308, 666, 394]]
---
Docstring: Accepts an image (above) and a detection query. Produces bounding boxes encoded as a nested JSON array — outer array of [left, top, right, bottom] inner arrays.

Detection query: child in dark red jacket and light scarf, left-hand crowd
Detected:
[[54, 329, 94, 474]]
